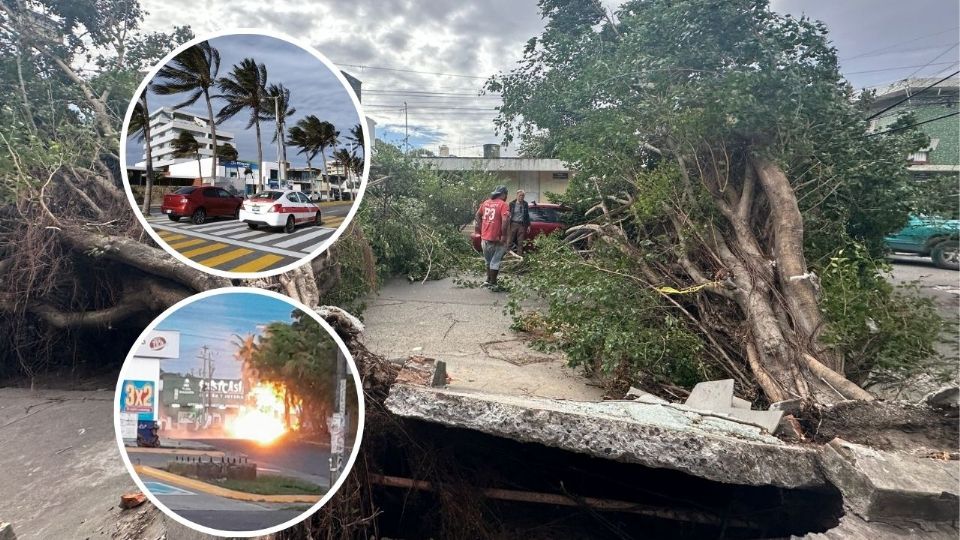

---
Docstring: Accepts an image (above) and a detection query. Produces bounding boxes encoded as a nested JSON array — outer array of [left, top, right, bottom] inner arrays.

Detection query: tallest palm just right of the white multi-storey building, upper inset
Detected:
[[216, 58, 267, 191]]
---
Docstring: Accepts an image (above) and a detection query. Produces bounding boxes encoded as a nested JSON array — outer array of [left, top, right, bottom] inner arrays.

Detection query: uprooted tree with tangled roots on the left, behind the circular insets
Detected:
[[0, 0, 376, 382]]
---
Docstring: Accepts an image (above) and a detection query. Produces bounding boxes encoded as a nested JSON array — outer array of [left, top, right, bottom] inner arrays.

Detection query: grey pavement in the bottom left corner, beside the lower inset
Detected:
[[0, 388, 211, 540]]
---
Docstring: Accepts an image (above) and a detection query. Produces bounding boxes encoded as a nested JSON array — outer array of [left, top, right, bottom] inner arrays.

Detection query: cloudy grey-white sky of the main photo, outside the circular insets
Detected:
[[142, 0, 960, 156]]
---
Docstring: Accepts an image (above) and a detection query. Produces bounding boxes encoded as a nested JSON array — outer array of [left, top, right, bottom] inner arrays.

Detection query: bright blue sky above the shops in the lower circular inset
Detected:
[[156, 292, 295, 379]]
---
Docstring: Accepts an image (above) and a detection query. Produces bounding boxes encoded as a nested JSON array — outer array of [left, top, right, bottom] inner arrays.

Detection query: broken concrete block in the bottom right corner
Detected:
[[821, 439, 960, 523]]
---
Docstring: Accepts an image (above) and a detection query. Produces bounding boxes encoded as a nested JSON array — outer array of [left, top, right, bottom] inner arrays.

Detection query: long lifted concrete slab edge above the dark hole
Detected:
[[386, 384, 826, 488]]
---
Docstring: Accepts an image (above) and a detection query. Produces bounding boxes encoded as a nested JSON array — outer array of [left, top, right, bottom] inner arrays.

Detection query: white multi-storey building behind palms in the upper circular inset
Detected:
[[137, 107, 236, 169]]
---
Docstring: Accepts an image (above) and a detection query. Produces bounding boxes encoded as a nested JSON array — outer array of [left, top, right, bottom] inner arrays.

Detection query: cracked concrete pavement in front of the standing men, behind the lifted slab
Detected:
[[363, 278, 602, 401]]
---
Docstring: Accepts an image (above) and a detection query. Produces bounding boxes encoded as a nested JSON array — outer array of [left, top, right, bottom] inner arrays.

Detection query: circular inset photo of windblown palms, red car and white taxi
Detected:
[[120, 32, 374, 278]]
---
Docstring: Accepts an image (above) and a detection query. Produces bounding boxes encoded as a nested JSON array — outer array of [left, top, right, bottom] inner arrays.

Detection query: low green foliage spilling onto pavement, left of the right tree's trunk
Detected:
[[510, 236, 718, 390]]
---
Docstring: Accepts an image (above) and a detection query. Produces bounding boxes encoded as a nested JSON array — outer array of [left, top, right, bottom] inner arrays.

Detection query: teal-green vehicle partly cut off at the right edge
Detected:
[[884, 216, 960, 270]]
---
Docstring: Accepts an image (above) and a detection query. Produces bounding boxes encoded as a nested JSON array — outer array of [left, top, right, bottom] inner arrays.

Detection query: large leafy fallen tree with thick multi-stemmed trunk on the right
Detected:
[[488, 0, 935, 403]]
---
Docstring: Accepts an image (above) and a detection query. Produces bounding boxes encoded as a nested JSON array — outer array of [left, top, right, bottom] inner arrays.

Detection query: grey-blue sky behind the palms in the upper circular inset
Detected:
[[127, 35, 360, 166]]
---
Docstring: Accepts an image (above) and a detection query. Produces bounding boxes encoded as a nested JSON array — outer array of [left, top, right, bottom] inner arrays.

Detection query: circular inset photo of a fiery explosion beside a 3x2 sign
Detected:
[[114, 287, 364, 537]]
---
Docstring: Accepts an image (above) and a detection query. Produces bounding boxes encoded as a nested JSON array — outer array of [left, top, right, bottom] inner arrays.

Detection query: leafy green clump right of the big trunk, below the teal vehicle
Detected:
[[820, 243, 944, 384]]
